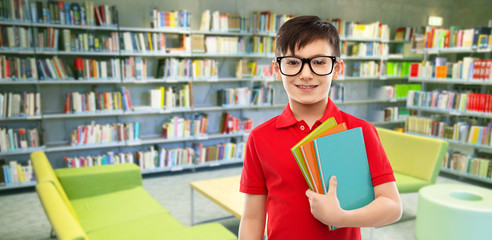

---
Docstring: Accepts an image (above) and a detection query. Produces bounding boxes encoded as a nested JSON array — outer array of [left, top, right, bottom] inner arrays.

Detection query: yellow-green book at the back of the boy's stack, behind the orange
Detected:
[[290, 117, 337, 191]]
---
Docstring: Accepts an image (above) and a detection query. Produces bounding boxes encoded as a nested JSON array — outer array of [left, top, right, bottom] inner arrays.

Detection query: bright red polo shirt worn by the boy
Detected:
[[240, 100, 395, 240]]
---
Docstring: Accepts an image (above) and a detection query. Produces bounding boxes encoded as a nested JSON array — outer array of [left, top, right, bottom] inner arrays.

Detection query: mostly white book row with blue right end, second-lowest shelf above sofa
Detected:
[[71, 121, 140, 146]]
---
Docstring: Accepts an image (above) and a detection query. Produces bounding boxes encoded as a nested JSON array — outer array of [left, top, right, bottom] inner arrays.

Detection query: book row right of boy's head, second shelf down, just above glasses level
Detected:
[[341, 41, 389, 57]]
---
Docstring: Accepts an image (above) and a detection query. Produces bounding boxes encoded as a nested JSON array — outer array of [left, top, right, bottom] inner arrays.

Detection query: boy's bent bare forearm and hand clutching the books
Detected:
[[306, 177, 402, 227]]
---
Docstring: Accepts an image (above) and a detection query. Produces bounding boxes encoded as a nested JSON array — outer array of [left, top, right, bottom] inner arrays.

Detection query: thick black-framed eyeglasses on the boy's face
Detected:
[[277, 56, 340, 76]]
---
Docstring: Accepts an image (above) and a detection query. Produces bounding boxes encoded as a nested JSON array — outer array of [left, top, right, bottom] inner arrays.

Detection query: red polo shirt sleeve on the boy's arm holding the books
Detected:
[[363, 123, 395, 186]]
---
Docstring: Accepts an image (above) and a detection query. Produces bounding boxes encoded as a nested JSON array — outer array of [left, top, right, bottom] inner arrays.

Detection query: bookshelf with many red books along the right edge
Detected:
[[406, 27, 492, 184]]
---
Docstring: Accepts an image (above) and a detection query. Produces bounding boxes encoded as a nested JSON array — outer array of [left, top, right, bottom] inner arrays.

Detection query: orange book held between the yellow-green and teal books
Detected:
[[300, 123, 347, 194]]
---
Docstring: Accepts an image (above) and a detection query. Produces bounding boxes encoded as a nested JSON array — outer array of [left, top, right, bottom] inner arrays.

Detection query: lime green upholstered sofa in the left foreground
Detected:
[[31, 151, 237, 240]]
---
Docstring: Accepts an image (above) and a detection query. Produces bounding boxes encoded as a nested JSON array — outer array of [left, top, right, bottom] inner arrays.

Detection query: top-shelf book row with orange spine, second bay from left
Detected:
[[150, 9, 192, 28]]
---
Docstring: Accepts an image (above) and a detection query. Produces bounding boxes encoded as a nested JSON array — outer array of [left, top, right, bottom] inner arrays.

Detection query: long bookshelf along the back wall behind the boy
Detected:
[[0, 6, 406, 190]]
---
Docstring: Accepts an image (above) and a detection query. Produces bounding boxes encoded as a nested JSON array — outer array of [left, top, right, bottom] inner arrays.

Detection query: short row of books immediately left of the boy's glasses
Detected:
[[236, 59, 274, 79]]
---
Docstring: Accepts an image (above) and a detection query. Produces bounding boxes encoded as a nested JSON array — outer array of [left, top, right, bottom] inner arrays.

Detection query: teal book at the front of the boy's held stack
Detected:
[[313, 127, 374, 210]]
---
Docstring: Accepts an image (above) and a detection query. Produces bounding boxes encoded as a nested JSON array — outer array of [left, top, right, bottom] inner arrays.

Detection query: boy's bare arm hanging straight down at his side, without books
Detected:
[[239, 194, 266, 240]]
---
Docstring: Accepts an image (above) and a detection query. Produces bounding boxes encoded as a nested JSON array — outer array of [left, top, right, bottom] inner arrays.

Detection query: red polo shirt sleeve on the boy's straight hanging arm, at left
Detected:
[[239, 130, 267, 194]]
